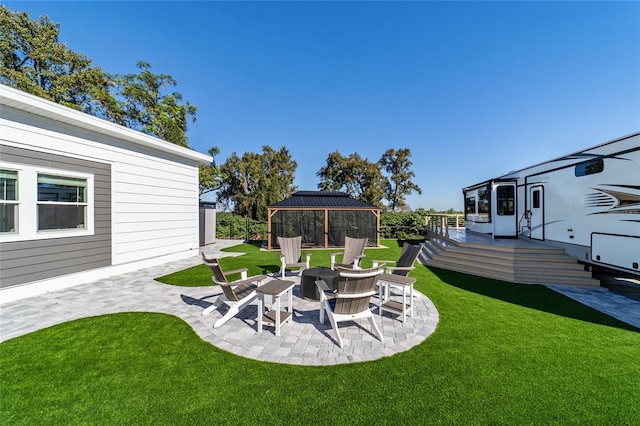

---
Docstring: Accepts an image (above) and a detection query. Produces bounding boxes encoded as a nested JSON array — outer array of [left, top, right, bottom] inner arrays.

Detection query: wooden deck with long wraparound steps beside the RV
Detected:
[[420, 229, 600, 286]]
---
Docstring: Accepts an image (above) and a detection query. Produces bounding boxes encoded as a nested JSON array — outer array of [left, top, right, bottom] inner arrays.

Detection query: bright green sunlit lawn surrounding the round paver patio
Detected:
[[0, 241, 640, 425]]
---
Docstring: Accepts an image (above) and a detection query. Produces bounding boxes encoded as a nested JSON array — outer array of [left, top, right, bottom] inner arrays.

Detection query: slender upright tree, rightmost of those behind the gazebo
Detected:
[[378, 148, 422, 211]]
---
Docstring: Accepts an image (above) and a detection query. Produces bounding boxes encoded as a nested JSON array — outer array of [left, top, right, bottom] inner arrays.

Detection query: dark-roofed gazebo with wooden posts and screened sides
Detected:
[[267, 191, 380, 250]]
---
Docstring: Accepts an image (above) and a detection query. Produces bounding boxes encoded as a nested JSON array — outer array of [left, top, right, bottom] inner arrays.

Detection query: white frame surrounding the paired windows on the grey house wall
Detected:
[[0, 162, 95, 242]]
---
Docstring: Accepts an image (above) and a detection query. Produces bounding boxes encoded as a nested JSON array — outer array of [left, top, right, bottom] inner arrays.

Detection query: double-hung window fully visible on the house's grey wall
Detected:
[[38, 174, 87, 231]]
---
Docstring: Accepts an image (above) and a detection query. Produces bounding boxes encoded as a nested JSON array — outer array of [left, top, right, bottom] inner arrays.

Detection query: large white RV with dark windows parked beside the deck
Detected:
[[462, 132, 640, 275]]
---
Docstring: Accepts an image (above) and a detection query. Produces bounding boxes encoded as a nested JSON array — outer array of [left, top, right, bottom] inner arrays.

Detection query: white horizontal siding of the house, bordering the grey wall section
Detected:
[[0, 102, 205, 265]]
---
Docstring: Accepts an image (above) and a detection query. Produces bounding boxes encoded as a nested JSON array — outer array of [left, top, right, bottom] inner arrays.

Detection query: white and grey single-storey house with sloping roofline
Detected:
[[0, 85, 211, 303]]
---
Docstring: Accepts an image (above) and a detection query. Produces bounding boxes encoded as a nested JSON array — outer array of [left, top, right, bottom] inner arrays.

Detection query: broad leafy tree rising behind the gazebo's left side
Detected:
[[218, 146, 297, 220]]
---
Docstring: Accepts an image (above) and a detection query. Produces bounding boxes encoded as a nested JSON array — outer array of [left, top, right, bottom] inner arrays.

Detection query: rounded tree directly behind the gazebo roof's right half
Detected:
[[316, 151, 385, 206]]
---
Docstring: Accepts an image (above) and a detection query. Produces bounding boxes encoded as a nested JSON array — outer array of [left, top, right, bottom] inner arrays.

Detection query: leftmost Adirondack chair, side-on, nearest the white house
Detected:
[[202, 253, 267, 328]]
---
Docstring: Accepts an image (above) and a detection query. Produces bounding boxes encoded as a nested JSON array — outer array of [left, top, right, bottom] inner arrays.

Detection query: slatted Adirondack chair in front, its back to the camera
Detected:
[[316, 265, 384, 348]]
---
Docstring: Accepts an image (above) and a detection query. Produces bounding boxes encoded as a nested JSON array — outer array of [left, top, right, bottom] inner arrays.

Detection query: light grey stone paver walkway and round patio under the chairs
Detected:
[[0, 244, 439, 365]]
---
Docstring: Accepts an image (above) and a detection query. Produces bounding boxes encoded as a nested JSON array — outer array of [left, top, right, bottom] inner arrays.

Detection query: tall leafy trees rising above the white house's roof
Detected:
[[0, 5, 196, 147]]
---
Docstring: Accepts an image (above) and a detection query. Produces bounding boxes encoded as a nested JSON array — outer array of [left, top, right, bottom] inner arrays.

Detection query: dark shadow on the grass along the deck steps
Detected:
[[428, 267, 640, 332]]
